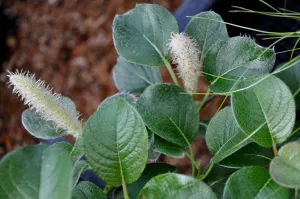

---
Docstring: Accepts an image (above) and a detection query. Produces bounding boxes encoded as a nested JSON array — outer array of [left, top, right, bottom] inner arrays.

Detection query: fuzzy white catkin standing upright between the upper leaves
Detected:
[[168, 33, 202, 92]]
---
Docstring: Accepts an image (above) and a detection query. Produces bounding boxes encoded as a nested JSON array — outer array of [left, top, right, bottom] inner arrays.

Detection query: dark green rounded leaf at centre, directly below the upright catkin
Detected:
[[136, 84, 199, 146]]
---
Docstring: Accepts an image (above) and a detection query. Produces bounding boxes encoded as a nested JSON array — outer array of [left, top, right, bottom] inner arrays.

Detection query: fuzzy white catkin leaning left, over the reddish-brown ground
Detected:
[[8, 71, 82, 137]]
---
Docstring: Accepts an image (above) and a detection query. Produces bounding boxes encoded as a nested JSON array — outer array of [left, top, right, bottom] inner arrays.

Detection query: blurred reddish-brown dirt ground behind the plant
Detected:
[[0, 0, 227, 172]]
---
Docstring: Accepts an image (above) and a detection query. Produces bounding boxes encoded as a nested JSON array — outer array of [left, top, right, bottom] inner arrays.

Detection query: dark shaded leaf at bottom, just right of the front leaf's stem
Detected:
[[115, 163, 176, 199]]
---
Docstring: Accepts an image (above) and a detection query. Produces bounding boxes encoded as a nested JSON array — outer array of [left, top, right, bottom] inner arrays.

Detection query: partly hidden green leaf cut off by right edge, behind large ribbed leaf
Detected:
[[276, 57, 300, 110]]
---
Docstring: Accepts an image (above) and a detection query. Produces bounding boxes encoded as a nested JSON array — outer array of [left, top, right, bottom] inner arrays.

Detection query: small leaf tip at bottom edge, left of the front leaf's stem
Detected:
[[72, 181, 107, 199]]
